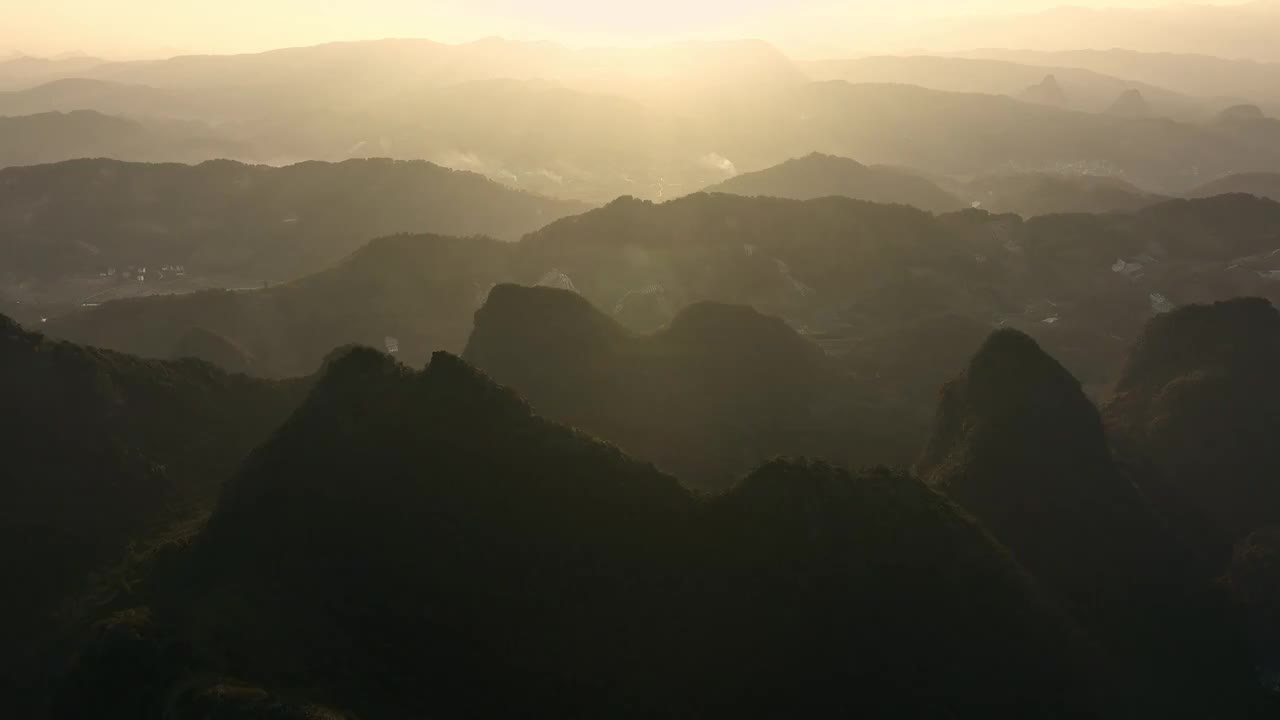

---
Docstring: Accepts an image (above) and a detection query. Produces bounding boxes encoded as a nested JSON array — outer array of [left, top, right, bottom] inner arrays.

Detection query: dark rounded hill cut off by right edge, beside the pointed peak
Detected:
[[1106, 299, 1280, 556]]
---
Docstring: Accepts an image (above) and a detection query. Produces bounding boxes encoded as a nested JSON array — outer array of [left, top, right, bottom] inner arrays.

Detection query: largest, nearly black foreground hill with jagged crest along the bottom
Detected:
[[49, 350, 1105, 717]]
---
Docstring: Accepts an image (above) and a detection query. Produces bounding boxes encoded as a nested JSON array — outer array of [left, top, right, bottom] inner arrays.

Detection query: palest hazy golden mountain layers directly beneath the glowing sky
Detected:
[[0, 40, 1280, 201]]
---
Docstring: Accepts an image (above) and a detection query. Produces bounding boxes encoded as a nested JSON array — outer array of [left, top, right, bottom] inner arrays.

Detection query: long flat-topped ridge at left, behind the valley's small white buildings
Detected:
[[0, 160, 586, 285]]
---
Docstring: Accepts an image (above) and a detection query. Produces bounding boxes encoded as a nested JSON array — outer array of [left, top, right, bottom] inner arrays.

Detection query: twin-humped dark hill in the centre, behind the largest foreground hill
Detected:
[[463, 284, 937, 489]]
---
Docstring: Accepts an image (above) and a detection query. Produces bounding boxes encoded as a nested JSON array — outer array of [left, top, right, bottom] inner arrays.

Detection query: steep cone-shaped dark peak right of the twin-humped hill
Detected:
[[918, 329, 1151, 597]]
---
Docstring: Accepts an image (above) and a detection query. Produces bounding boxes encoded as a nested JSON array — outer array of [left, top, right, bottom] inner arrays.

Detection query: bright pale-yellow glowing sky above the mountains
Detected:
[[0, 0, 1259, 56]]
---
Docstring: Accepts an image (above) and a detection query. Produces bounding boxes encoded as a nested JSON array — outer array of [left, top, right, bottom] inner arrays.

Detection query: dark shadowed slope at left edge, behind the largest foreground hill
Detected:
[[0, 316, 305, 696]]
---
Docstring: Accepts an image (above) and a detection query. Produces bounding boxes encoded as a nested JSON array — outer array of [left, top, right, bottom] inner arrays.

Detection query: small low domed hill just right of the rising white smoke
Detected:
[[707, 152, 960, 213]]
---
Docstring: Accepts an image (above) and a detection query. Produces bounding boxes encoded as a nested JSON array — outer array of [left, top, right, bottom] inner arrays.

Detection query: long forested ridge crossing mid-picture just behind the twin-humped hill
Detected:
[[46, 188, 1280, 407]]
